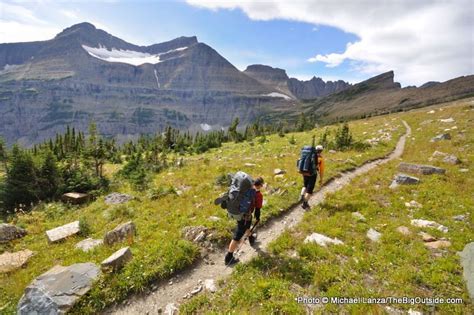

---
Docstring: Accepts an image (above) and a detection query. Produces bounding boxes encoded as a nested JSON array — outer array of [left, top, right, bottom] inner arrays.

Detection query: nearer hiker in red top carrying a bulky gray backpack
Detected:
[[214, 171, 264, 265]]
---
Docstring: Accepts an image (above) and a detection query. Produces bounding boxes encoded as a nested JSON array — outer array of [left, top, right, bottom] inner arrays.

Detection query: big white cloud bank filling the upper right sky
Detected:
[[187, 0, 474, 85]]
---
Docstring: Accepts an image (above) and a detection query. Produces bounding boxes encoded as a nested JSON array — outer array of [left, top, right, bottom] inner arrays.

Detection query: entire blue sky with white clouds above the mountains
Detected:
[[0, 0, 474, 85]]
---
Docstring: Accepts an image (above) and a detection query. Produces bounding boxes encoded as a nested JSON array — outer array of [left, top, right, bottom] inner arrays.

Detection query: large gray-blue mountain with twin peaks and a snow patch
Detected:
[[0, 23, 286, 145]]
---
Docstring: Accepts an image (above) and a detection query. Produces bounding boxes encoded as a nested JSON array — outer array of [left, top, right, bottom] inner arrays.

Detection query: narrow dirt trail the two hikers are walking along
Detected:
[[104, 121, 411, 315]]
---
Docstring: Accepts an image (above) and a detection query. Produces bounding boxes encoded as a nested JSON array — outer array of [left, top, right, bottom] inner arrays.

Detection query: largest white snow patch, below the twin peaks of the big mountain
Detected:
[[82, 45, 188, 66]]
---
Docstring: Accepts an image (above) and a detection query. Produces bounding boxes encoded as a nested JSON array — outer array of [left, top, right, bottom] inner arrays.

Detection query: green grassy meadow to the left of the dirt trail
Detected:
[[0, 103, 420, 314]]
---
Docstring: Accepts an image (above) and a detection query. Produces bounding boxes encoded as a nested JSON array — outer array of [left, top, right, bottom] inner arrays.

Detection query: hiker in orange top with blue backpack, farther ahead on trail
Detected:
[[296, 136, 324, 210]]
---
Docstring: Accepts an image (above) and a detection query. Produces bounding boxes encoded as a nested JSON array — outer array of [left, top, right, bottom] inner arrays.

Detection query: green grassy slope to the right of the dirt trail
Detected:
[[181, 100, 474, 314]]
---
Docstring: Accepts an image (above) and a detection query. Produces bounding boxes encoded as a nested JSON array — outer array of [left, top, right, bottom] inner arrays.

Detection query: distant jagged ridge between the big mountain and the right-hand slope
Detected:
[[244, 65, 351, 100]]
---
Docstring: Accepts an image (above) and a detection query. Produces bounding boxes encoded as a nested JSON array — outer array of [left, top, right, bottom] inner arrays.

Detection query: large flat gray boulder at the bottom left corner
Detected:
[[17, 263, 100, 315]]
